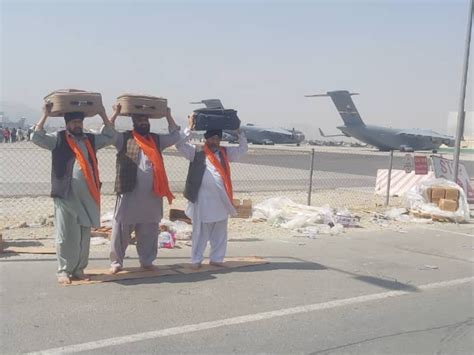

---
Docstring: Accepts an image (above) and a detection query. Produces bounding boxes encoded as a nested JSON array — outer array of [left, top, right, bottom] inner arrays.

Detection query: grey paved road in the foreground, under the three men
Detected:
[[0, 224, 474, 354]]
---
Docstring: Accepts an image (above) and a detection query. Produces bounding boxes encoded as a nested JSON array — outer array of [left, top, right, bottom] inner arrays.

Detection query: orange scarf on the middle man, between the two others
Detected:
[[132, 130, 174, 204]]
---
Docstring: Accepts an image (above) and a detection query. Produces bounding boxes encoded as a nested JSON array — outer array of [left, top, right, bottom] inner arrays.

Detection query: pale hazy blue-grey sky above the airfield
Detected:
[[0, 0, 474, 138]]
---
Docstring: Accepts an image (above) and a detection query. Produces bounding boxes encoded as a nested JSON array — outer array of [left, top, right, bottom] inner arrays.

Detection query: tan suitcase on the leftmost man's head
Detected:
[[44, 89, 103, 117]]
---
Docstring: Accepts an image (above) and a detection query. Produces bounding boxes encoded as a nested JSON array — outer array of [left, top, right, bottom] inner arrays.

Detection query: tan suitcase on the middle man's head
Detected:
[[117, 94, 168, 118]]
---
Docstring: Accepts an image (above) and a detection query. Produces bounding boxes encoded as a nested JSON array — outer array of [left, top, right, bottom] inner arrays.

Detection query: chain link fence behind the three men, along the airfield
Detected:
[[0, 135, 472, 228]]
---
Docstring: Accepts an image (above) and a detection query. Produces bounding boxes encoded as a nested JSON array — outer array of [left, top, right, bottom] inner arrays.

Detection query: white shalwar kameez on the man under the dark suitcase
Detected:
[[176, 128, 248, 264]]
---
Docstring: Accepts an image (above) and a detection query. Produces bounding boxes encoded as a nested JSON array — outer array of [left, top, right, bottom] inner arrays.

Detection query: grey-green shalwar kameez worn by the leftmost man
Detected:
[[31, 126, 115, 276]]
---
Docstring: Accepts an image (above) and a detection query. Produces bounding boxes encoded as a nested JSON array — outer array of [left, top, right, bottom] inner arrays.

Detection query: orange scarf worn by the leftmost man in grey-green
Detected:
[[66, 133, 100, 206]]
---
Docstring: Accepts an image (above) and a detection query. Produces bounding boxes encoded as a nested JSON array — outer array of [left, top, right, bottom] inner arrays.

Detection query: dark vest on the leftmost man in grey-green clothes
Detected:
[[51, 131, 97, 198]]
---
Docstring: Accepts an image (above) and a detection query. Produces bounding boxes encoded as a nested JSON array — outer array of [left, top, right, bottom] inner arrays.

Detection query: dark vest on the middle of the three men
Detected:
[[115, 131, 161, 194]]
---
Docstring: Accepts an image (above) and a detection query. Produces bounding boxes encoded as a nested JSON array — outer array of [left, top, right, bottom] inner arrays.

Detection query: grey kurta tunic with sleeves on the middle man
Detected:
[[114, 128, 180, 224]]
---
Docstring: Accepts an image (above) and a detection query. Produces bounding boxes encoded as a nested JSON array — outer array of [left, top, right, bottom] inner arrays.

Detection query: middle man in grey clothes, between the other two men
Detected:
[[110, 104, 180, 274]]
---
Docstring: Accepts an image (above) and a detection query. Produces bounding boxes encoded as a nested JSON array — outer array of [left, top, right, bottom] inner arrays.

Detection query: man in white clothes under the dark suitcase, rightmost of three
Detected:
[[176, 113, 248, 269]]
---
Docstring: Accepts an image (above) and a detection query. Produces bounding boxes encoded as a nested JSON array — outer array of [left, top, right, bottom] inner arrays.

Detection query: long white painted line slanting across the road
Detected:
[[29, 277, 474, 354]]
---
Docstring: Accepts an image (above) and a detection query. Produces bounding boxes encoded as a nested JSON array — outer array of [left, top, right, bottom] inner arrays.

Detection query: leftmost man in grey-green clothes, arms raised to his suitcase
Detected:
[[31, 104, 115, 284]]
